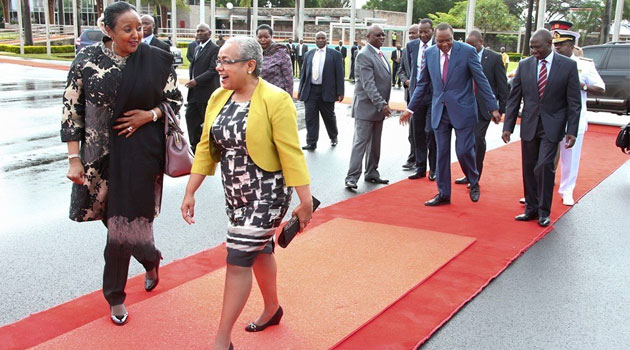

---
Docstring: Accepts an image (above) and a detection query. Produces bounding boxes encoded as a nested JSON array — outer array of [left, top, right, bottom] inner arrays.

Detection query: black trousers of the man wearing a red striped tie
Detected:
[[521, 119, 559, 217]]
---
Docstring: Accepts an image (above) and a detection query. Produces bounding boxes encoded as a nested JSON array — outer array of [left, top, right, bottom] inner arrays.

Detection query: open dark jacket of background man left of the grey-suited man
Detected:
[[298, 48, 344, 102]]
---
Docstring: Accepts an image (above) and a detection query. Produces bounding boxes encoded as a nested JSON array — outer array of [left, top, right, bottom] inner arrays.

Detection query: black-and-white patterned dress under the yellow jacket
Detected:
[[210, 99, 293, 267]]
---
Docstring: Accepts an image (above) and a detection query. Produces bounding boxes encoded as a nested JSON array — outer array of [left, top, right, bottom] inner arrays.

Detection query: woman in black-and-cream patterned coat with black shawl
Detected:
[[61, 2, 182, 325]]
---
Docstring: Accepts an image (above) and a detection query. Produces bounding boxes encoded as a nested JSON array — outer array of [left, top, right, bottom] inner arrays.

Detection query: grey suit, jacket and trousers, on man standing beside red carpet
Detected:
[[346, 45, 392, 182]]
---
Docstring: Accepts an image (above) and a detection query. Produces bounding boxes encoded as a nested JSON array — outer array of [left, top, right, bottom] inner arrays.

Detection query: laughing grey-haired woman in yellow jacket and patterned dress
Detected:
[[181, 37, 313, 350]]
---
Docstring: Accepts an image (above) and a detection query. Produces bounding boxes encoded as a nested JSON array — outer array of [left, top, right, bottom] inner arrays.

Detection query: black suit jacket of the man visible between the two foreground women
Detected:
[[188, 40, 219, 103]]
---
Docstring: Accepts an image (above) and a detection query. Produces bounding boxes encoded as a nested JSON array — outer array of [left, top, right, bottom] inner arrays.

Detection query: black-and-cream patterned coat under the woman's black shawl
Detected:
[[61, 42, 183, 221]]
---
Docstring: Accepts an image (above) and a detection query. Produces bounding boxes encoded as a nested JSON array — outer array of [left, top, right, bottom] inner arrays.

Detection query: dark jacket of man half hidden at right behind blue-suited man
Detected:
[[476, 48, 509, 120]]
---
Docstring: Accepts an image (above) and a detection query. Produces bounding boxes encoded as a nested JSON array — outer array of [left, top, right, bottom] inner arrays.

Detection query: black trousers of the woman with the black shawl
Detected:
[[103, 221, 160, 306]]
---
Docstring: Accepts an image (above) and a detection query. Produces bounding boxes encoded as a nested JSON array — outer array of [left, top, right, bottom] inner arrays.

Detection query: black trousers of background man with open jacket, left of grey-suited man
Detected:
[[304, 84, 339, 145]]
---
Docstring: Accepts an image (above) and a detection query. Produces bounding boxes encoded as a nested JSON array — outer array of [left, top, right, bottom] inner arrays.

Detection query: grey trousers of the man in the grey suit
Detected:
[[346, 118, 383, 182]]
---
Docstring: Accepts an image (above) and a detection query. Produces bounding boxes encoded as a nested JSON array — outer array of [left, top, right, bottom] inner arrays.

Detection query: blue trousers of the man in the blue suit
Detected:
[[435, 106, 479, 198]]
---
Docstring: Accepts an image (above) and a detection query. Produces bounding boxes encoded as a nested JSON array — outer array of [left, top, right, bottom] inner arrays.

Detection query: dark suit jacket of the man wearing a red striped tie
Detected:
[[503, 53, 582, 142]]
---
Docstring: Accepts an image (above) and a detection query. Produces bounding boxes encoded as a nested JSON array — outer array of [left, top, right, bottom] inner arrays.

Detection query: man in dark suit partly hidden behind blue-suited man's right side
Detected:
[[455, 30, 509, 185]]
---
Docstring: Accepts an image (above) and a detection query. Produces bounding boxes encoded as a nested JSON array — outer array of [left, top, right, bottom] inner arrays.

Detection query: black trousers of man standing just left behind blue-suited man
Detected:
[[407, 104, 437, 171]]
